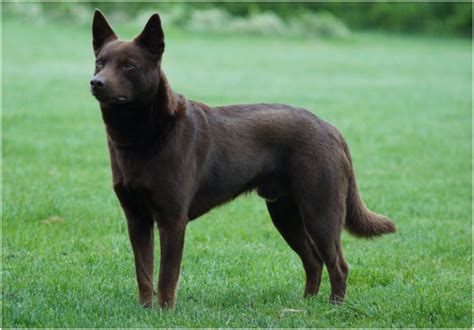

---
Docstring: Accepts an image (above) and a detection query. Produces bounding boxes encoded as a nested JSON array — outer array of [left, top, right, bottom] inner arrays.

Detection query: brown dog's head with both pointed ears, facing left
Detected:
[[90, 10, 165, 106]]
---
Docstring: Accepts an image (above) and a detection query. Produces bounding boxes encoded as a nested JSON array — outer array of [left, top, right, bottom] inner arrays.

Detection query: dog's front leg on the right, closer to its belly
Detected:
[[158, 221, 185, 308]]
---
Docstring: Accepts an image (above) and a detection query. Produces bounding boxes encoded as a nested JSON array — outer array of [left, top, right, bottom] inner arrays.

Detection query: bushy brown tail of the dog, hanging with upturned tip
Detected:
[[344, 143, 397, 238]]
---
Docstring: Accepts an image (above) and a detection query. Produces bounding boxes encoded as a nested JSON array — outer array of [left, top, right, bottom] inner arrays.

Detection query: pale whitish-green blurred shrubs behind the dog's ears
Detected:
[[5, 2, 351, 39]]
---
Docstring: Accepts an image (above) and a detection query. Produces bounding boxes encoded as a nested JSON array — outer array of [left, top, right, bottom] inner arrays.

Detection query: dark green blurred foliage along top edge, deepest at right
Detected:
[[90, 1, 472, 36]]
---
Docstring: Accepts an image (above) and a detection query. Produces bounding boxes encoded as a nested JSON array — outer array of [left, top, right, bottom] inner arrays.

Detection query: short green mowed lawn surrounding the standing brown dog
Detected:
[[2, 19, 472, 327]]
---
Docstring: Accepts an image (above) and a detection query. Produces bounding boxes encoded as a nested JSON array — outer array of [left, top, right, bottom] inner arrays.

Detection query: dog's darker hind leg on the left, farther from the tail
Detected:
[[267, 196, 323, 297]]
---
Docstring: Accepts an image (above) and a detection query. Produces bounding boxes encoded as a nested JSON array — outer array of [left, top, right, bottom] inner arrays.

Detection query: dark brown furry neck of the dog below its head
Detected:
[[101, 70, 186, 149]]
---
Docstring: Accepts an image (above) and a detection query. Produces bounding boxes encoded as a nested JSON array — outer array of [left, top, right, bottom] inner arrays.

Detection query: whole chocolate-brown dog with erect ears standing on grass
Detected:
[[90, 11, 395, 307]]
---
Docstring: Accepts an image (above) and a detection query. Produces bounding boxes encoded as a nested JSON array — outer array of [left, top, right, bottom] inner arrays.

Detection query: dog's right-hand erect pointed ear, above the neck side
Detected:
[[134, 13, 165, 60]]
